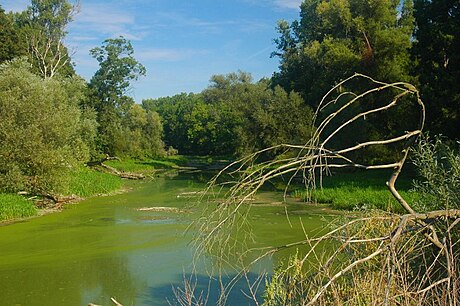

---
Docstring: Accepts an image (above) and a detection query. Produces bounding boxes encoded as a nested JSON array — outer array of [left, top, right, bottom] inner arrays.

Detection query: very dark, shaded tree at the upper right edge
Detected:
[[413, 0, 460, 139]]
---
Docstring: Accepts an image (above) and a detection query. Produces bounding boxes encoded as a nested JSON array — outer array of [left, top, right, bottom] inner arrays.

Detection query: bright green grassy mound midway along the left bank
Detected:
[[67, 167, 123, 197]]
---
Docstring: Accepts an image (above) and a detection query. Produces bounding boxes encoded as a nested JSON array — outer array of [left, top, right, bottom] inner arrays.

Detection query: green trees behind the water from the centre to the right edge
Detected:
[[143, 0, 460, 155]]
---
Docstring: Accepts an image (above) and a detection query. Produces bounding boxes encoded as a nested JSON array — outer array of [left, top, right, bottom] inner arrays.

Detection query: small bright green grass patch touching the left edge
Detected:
[[0, 193, 37, 221]]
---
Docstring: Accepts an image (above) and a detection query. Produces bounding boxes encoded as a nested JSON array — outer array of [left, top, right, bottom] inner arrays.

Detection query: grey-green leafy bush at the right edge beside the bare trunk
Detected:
[[412, 137, 460, 211]]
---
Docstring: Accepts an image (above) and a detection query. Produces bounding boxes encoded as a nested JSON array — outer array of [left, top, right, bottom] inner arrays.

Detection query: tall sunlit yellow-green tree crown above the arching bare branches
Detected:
[[273, 0, 413, 106]]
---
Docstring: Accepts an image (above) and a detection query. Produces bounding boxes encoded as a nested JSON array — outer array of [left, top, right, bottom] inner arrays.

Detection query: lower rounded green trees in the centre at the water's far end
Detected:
[[143, 72, 313, 155]]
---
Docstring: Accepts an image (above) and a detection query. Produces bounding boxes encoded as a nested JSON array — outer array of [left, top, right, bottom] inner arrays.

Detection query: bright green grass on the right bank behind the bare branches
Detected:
[[292, 171, 419, 212]]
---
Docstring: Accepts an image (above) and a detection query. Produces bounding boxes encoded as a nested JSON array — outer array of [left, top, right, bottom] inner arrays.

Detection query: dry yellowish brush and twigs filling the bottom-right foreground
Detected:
[[264, 211, 460, 305]]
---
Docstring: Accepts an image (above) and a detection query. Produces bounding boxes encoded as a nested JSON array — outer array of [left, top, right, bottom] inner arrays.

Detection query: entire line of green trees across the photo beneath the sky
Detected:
[[0, 0, 460, 191]]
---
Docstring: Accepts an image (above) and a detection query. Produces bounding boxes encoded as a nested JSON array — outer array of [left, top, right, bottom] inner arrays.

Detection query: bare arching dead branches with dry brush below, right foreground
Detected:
[[183, 74, 450, 305]]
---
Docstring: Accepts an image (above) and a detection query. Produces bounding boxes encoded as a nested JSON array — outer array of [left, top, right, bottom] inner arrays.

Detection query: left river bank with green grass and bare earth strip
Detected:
[[0, 155, 228, 226]]
